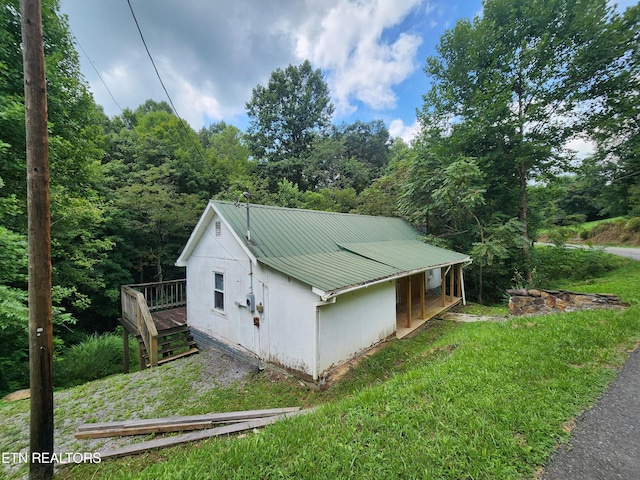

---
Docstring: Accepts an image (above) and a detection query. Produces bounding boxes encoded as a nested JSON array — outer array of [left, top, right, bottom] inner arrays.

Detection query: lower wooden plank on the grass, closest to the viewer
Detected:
[[89, 412, 297, 460]]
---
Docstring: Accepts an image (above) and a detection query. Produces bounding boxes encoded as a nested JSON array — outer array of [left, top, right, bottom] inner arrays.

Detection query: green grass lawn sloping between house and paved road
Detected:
[[5, 261, 640, 479]]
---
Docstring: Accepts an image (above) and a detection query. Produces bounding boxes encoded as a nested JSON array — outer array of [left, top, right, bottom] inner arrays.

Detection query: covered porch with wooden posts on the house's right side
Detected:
[[396, 263, 466, 338]]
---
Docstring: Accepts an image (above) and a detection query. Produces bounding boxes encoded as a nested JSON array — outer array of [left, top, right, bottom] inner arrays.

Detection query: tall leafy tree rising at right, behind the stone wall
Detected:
[[419, 0, 632, 280]]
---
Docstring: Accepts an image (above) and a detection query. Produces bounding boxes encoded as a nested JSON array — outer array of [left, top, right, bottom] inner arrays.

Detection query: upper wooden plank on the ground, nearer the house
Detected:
[[77, 407, 300, 432]]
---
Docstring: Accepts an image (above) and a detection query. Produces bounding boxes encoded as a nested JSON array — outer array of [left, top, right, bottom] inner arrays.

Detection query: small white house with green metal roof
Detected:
[[176, 201, 470, 381]]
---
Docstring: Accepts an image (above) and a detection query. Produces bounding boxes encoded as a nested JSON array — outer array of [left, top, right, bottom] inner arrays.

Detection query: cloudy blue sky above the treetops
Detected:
[[61, 0, 635, 146]]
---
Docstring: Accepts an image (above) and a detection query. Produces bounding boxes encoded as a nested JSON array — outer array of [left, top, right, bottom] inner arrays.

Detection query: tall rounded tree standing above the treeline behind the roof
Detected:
[[246, 60, 333, 190]]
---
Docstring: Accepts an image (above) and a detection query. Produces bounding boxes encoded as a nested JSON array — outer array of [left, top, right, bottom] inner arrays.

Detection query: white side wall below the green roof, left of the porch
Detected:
[[318, 281, 396, 372]]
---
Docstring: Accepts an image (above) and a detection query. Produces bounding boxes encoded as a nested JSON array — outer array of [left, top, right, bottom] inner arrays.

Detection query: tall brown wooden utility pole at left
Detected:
[[20, 0, 53, 480]]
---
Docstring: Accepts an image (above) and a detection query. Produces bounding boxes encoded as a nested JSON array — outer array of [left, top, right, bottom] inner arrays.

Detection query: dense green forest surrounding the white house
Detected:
[[0, 0, 640, 394]]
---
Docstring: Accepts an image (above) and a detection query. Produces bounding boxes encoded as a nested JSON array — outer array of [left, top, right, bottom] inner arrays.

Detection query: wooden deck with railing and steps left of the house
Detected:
[[119, 279, 198, 373]]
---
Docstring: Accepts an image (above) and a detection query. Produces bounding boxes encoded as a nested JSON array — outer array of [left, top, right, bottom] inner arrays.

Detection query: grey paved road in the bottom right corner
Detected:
[[542, 348, 640, 480]]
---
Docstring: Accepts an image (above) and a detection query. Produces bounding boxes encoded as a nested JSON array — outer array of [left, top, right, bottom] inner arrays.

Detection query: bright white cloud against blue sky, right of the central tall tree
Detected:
[[296, 0, 422, 116]]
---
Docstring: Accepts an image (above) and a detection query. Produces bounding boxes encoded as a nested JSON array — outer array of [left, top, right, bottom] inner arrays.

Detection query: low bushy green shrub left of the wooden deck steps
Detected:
[[53, 333, 137, 387]]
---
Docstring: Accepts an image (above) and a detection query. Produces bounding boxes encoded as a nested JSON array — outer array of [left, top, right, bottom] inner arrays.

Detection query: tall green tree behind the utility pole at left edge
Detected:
[[0, 0, 112, 330]]
